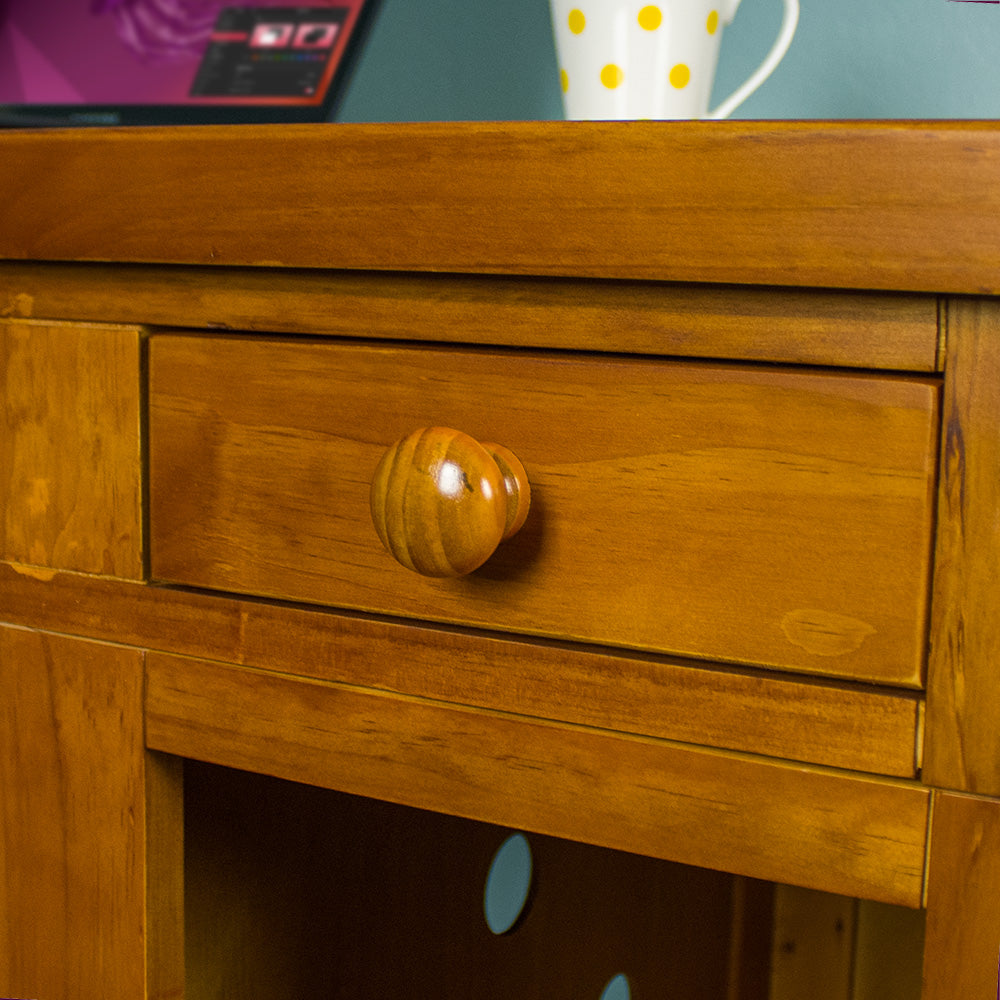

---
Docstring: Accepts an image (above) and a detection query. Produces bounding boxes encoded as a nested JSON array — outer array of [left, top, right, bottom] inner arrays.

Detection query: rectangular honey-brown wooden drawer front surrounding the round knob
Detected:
[[149, 334, 938, 686]]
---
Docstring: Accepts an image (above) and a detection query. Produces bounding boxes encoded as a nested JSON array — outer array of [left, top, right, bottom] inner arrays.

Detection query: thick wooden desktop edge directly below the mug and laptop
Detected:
[[0, 121, 1000, 292]]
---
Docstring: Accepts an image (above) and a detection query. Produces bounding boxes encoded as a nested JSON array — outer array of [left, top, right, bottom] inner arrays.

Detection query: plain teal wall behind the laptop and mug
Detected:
[[336, 0, 1000, 122]]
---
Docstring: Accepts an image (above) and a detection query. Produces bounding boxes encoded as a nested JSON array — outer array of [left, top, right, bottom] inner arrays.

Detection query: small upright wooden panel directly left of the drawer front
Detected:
[[0, 320, 142, 578]]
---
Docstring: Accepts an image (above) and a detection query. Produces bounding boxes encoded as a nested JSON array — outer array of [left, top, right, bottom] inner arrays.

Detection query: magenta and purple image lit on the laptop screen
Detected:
[[0, 0, 363, 105]]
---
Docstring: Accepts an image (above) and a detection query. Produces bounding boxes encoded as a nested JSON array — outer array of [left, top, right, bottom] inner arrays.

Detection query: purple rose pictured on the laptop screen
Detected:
[[90, 0, 225, 62]]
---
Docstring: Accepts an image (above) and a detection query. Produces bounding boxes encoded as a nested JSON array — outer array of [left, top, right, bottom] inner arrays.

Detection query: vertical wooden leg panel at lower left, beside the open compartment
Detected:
[[0, 628, 181, 1000]]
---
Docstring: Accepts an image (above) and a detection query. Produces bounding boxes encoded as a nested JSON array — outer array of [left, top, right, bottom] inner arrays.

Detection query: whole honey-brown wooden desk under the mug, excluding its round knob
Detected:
[[0, 123, 1000, 1000]]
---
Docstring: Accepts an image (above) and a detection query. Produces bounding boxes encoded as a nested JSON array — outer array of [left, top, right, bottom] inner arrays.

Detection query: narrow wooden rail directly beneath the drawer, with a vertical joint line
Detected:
[[0, 566, 920, 777]]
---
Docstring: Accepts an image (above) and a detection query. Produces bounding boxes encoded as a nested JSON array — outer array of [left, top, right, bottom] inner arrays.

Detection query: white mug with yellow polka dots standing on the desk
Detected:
[[550, 0, 799, 120]]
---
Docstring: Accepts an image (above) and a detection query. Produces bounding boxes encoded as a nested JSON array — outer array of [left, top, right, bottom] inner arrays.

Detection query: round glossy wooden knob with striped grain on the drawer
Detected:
[[371, 427, 531, 576]]
